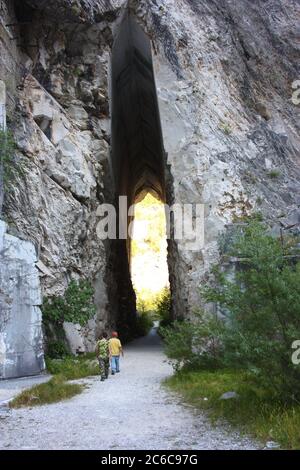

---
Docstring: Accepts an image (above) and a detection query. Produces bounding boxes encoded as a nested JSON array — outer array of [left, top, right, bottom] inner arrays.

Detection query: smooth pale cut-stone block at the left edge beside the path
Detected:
[[0, 221, 45, 379]]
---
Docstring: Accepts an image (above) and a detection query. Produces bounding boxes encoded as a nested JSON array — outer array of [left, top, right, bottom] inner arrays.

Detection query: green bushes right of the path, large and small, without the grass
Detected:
[[165, 221, 300, 402]]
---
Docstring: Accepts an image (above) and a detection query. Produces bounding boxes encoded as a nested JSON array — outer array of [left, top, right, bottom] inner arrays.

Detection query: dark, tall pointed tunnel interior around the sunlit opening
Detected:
[[111, 12, 167, 337]]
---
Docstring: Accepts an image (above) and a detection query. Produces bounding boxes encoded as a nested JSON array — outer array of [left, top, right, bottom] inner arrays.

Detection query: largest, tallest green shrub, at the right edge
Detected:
[[203, 221, 300, 400]]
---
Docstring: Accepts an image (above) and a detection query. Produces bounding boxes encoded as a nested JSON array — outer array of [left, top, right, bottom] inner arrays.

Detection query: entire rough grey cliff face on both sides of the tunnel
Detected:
[[2, 0, 300, 370]]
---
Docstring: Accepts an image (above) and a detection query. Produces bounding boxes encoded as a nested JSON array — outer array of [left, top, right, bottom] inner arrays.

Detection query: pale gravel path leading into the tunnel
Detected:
[[0, 330, 260, 450]]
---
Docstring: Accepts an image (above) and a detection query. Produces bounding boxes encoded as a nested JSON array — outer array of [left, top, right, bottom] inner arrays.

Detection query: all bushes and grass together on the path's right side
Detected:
[[163, 219, 300, 448]]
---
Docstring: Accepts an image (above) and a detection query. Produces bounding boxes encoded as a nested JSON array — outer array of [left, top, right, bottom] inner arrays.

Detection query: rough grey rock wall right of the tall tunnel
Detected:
[[135, 0, 300, 315]]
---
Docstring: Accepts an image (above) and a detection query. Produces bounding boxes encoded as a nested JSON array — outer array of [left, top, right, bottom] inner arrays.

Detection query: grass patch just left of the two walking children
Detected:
[[46, 354, 99, 380]]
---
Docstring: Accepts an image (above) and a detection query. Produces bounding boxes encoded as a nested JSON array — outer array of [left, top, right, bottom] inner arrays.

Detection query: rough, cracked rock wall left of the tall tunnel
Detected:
[[1, 2, 125, 360]]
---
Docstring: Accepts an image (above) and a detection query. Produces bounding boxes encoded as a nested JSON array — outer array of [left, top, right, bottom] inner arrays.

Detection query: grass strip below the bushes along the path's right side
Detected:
[[165, 370, 300, 450]]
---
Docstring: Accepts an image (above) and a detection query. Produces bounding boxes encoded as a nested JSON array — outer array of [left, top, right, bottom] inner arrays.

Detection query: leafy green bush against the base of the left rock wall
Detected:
[[42, 280, 96, 325]]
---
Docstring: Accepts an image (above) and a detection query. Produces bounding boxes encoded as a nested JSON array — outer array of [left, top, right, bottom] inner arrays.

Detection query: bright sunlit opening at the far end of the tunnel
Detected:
[[131, 193, 169, 311]]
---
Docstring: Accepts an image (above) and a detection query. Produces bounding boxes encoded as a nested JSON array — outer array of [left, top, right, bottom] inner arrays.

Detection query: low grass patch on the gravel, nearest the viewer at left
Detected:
[[10, 375, 84, 408]]
